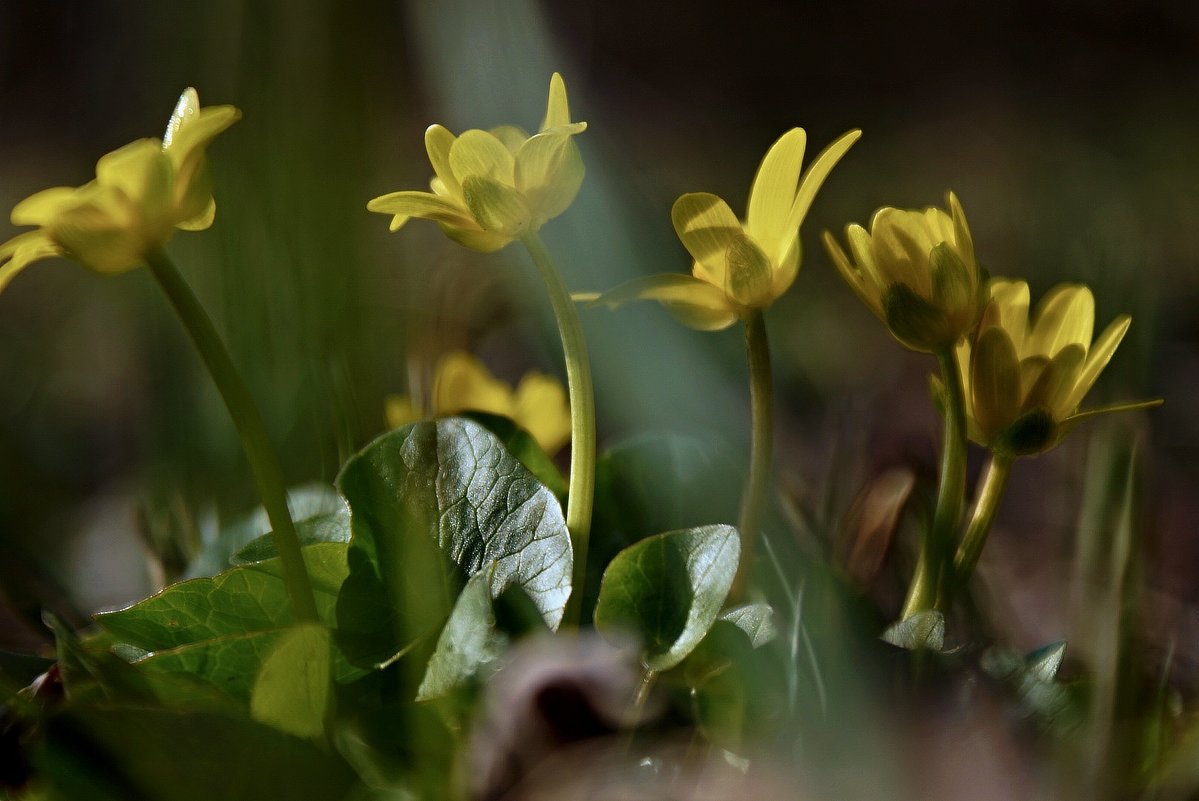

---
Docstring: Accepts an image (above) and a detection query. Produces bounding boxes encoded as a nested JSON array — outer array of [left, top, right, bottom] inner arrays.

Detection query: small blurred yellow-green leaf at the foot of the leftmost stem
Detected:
[[249, 624, 332, 737]]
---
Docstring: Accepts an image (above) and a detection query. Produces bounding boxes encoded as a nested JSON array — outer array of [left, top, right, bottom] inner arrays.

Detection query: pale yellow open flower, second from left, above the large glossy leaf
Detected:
[[367, 72, 588, 252]]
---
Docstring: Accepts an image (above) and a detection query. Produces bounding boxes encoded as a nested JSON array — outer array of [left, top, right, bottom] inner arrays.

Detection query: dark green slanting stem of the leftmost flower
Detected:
[[146, 251, 319, 622]]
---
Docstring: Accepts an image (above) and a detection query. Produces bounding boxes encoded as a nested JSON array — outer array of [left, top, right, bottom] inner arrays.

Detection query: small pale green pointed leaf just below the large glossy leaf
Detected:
[[416, 568, 507, 700]]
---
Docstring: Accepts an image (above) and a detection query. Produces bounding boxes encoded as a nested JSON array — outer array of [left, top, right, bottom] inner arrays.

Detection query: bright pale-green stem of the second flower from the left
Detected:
[[520, 233, 596, 625]]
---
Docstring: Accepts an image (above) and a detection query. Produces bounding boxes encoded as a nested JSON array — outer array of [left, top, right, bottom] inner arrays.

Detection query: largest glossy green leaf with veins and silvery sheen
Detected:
[[337, 417, 572, 666]]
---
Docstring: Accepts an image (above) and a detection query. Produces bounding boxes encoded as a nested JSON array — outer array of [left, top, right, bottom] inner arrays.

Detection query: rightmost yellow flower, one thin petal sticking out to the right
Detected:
[[956, 278, 1161, 456]]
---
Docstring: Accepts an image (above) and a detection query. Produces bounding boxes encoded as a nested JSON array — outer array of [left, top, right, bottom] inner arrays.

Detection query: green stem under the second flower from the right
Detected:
[[899, 348, 966, 620]]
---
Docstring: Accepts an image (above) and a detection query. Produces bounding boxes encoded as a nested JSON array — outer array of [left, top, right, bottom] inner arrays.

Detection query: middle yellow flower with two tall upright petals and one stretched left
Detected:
[[577, 128, 862, 331]]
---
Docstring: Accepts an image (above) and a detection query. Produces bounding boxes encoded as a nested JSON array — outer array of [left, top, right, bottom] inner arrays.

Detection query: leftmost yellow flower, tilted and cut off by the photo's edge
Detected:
[[0, 89, 241, 289]]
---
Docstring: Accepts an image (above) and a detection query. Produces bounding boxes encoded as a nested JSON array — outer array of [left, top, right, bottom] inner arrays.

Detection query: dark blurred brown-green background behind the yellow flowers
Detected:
[[0, 0, 1199, 676]]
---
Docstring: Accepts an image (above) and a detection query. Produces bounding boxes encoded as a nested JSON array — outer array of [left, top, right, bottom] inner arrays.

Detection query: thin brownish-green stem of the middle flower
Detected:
[[729, 311, 775, 601]]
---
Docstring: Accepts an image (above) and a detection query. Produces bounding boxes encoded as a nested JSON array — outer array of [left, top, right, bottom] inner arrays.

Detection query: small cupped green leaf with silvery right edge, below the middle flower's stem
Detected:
[[595, 525, 741, 670]]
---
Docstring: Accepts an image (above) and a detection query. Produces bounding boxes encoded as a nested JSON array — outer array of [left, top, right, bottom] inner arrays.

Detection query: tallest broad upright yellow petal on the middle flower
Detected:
[[746, 128, 808, 256]]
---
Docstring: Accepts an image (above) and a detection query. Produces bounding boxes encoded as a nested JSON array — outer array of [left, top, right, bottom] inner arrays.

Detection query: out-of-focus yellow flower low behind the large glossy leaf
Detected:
[[386, 350, 571, 454]]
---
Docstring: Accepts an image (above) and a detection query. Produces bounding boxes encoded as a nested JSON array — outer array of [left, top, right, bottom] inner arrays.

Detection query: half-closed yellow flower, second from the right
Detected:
[[824, 192, 987, 353]]
